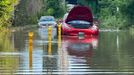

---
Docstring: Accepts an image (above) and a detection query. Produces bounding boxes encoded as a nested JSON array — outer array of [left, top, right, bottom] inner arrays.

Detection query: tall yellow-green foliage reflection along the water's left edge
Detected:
[[0, 31, 19, 75]]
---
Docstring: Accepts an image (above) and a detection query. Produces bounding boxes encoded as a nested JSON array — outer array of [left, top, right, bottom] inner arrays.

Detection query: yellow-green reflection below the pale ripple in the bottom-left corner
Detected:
[[0, 55, 19, 75]]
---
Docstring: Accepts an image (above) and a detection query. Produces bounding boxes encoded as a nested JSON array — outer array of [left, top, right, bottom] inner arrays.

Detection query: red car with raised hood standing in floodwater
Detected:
[[62, 6, 99, 35]]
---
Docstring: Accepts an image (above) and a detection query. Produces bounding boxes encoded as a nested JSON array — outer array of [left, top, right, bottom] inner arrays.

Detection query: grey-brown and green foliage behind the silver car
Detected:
[[13, 0, 66, 26]]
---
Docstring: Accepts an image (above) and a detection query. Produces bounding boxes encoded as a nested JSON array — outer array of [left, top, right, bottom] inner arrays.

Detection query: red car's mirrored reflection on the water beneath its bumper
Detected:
[[62, 36, 98, 56]]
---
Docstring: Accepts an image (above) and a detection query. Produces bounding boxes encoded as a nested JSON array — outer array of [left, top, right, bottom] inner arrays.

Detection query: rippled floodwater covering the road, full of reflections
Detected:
[[0, 28, 134, 75]]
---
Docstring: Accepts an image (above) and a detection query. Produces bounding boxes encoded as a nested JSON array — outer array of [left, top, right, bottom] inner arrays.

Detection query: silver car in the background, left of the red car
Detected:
[[38, 16, 57, 27]]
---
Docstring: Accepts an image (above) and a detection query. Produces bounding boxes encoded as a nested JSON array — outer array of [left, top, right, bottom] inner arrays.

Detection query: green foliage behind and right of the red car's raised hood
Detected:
[[66, 0, 134, 29]]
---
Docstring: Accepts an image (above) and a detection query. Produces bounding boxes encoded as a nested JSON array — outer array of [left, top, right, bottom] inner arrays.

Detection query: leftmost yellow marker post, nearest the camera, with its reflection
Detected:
[[28, 32, 34, 69]]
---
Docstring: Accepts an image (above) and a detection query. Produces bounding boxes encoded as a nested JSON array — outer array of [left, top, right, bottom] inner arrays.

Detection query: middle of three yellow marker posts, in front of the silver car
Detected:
[[48, 26, 52, 55]]
